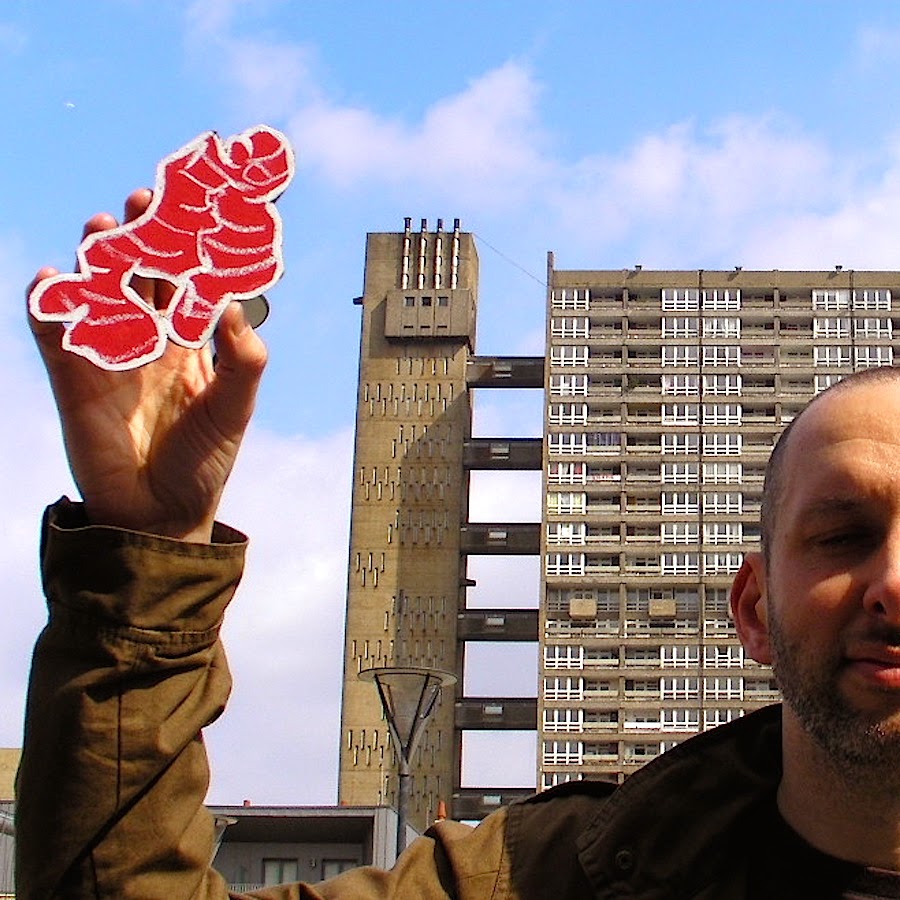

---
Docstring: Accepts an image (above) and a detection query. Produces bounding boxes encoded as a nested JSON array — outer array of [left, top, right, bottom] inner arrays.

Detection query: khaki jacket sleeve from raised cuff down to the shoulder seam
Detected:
[[16, 500, 510, 900]]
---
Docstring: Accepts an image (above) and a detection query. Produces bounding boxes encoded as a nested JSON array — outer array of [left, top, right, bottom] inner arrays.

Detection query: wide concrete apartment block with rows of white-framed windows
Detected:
[[539, 257, 900, 787]]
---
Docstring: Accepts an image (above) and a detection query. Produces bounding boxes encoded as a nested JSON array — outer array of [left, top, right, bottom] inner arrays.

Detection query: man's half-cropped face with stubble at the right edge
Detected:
[[761, 381, 900, 765]]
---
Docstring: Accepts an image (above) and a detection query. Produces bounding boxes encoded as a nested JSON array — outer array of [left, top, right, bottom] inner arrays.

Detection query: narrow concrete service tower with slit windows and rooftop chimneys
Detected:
[[339, 220, 486, 828]]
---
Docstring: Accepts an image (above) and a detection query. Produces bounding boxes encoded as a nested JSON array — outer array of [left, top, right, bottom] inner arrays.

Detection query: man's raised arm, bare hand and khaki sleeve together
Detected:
[[17, 191, 266, 900]]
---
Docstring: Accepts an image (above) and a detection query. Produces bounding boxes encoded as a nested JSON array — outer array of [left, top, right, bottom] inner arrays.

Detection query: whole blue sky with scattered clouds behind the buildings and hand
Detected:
[[0, 0, 900, 803]]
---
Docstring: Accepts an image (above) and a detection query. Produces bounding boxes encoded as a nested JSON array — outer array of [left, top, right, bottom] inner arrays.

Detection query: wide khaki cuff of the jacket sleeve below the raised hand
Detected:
[[41, 497, 247, 632]]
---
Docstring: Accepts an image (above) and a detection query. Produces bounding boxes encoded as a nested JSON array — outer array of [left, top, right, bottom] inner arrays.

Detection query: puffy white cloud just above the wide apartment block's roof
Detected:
[[548, 116, 836, 268]]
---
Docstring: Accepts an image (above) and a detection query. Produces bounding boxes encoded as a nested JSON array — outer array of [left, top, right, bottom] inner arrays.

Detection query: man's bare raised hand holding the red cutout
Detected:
[[28, 189, 266, 542]]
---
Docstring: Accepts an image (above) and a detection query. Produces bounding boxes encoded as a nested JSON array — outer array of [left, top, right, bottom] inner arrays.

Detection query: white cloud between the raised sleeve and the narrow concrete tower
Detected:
[[208, 430, 352, 803]]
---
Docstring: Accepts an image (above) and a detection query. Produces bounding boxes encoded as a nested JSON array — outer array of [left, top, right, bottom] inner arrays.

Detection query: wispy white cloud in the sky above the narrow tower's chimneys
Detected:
[[181, 9, 546, 206]]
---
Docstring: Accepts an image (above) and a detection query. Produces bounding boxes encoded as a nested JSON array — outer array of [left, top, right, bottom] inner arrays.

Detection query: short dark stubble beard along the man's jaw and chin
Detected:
[[769, 608, 900, 781]]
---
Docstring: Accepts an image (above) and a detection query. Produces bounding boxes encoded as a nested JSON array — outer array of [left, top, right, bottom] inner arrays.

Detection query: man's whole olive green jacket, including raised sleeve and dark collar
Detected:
[[17, 501, 780, 900]]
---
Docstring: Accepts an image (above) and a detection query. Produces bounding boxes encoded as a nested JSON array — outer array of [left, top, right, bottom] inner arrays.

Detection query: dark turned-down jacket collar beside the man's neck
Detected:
[[578, 705, 781, 898]]
